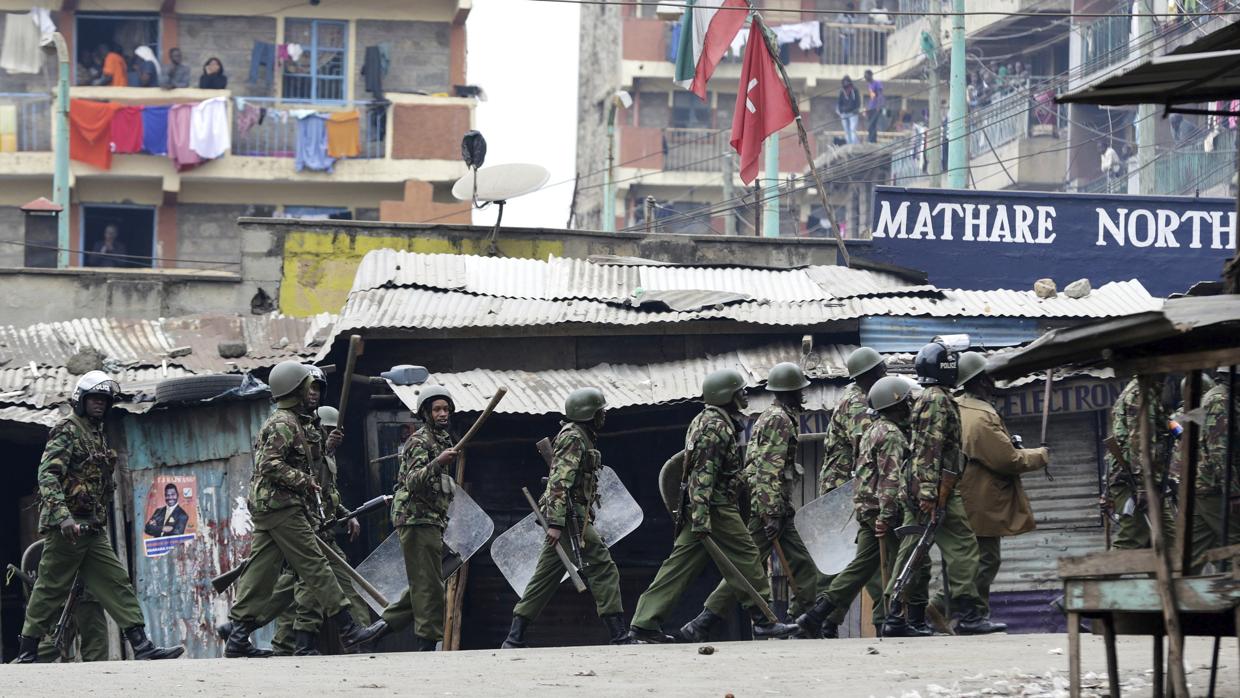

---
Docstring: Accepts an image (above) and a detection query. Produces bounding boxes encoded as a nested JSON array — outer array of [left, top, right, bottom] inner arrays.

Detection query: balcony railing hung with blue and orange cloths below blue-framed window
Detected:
[[232, 97, 391, 160]]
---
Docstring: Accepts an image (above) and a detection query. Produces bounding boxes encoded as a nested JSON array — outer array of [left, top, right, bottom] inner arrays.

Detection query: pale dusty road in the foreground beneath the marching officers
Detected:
[[0, 635, 1240, 698]]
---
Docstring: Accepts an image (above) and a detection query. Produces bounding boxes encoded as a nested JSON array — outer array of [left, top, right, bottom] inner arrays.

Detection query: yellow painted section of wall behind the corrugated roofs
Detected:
[[280, 231, 564, 316]]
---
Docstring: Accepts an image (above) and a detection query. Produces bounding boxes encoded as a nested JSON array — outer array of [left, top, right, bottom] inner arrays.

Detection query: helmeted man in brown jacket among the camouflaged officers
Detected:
[[956, 351, 1049, 619]]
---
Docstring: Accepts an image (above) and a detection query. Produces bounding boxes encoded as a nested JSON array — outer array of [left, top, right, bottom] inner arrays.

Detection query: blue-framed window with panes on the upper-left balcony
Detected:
[[283, 20, 348, 102]]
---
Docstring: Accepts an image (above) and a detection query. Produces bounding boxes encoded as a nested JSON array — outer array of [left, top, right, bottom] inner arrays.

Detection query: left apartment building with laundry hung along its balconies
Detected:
[[0, 0, 475, 276]]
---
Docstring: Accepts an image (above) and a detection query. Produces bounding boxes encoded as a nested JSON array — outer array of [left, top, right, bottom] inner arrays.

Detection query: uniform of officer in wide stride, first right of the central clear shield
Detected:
[[632, 405, 770, 632]]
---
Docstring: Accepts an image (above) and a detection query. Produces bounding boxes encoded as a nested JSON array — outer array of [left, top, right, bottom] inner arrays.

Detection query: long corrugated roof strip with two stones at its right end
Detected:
[[335, 281, 1161, 335]]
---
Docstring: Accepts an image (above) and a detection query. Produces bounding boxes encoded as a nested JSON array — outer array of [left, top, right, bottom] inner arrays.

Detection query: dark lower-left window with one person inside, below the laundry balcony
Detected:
[[82, 206, 155, 268]]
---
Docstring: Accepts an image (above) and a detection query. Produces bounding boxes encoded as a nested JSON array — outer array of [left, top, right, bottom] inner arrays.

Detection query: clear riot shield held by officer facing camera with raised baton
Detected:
[[353, 482, 495, 614]]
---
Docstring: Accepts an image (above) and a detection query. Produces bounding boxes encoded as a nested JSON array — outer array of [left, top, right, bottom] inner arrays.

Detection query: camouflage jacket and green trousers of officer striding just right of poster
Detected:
[[228, 408, 350, 625]]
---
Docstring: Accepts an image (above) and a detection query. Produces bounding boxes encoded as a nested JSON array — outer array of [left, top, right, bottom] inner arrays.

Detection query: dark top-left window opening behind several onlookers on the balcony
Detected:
[[73, 12, 164, 87]]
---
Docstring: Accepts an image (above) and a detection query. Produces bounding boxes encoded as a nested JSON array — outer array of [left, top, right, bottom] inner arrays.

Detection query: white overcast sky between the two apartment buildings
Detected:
[[466, 0, 578, 228]]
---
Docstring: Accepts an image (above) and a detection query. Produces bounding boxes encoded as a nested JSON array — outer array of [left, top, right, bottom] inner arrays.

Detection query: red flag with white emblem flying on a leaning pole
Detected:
[[732, 17, 795, 183]]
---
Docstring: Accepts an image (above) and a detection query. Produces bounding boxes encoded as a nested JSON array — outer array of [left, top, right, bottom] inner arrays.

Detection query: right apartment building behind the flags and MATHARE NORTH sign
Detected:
[[577, 0, 1240, 238]]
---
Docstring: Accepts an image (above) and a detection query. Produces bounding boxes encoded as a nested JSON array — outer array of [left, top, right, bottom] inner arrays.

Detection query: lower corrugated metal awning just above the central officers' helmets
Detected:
[[392, 342, 856, 414]]
